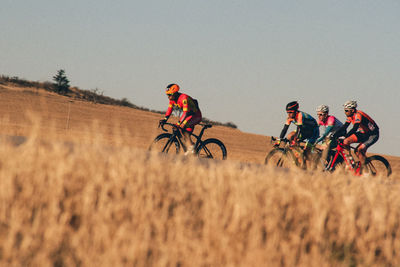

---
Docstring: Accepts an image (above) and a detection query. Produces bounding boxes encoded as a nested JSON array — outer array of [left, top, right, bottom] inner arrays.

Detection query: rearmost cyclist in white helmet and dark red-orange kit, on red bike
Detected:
[[334, 100, 379, 165]]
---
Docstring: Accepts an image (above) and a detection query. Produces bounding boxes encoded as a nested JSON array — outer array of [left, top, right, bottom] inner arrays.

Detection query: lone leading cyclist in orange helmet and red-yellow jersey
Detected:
[[160, 83, 202, 153]]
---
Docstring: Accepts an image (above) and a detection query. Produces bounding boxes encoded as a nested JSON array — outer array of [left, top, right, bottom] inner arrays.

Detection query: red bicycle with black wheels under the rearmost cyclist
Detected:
[[325, 138, 392, 177]]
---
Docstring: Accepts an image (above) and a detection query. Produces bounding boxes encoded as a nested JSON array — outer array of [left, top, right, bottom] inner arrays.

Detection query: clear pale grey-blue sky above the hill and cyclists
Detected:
[[0, 0, 400, 156]]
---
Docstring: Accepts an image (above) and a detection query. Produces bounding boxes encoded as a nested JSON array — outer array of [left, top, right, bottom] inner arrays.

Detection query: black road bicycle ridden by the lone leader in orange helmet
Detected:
[[149, 122, 227, 160]]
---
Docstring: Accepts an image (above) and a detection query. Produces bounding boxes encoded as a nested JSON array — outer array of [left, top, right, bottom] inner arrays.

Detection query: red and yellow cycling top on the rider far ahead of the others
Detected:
[[165, 94, 202, 132]]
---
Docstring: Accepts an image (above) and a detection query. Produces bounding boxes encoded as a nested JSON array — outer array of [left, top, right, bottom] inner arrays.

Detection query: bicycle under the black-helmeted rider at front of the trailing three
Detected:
[[264, 136, 315, 169]]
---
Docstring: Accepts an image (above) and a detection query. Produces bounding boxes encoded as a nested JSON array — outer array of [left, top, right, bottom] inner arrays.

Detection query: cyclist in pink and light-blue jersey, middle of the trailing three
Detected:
[[315, 105, 346, 163]]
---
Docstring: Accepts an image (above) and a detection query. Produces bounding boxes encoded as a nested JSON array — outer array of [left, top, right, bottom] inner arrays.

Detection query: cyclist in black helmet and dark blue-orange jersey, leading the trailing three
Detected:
[[275, 101, 319, 160]]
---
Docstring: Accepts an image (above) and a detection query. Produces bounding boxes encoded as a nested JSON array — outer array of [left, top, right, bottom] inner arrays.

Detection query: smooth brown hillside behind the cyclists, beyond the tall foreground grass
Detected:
[[0, 82, 400, 172]]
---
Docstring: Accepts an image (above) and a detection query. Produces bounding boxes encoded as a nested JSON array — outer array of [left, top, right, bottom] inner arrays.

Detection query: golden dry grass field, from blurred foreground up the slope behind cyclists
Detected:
[[0, 85, 400, 266]]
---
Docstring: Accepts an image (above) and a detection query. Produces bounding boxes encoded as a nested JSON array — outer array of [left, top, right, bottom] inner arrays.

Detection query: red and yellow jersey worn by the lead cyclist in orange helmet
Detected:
[[165, 94, 201, 127]]
